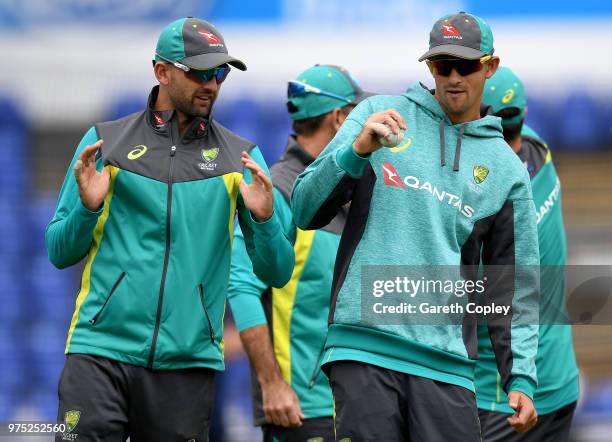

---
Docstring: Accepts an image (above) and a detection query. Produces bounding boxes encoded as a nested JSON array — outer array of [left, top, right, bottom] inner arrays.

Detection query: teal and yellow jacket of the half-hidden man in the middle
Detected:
[[228, 136, 346, 425]]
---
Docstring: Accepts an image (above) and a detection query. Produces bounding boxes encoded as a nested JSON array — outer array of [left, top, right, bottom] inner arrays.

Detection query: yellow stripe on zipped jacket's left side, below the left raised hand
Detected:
[[65, 165, 119, 353]]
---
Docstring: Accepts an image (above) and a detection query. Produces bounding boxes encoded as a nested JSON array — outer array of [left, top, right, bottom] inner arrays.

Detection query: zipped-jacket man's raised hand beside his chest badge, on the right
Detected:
[[240, 152, 274, 221]]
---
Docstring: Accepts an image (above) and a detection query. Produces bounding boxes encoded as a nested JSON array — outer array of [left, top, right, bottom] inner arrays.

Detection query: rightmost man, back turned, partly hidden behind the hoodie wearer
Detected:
[[475, 67, 578, 442]]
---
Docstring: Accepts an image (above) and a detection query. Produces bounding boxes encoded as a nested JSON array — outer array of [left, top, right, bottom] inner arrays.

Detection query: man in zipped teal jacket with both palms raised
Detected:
[[46, 17, 294, 442]]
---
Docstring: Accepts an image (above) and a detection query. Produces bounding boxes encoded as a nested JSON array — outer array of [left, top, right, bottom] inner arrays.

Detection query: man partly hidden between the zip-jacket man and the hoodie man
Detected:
[[228, 65, 371, 442]]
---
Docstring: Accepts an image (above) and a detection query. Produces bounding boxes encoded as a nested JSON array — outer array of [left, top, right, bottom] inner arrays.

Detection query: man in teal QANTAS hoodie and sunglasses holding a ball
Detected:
[[291, 12, 539, 442]]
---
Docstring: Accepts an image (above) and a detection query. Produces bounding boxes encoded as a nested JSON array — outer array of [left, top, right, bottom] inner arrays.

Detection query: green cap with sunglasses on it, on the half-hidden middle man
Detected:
[[287, 64, 374, 120]]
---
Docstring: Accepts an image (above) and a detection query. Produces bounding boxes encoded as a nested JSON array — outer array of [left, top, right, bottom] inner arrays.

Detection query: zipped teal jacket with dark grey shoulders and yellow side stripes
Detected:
[[46, 87, 294, 370]]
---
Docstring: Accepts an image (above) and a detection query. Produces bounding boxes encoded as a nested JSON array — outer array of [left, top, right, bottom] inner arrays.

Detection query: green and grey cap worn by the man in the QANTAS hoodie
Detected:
[[419, 11, 494, 61]]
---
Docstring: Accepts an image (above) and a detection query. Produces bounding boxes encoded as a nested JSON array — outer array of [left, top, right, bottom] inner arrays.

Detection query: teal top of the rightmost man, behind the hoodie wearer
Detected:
[[476, 125, 579, 415]]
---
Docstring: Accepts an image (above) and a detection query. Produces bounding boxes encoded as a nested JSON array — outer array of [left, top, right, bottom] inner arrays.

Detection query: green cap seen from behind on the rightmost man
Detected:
[[482, 66, 527, 126]]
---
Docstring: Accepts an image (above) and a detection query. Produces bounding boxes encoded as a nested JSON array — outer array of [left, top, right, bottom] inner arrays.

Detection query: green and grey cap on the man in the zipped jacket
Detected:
[[155, 17, 246, 71]]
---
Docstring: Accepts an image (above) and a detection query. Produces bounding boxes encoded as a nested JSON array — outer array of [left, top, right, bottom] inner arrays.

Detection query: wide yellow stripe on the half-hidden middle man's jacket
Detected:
[[272, 229, 315, 385]]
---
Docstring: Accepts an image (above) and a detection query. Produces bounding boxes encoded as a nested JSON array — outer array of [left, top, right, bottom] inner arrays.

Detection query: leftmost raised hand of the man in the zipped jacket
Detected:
[[73, 140, 110, 211]]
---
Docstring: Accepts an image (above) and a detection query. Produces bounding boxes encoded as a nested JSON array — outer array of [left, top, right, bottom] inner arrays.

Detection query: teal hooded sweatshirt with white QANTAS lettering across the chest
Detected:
[[292, 83, 539, 397]]
